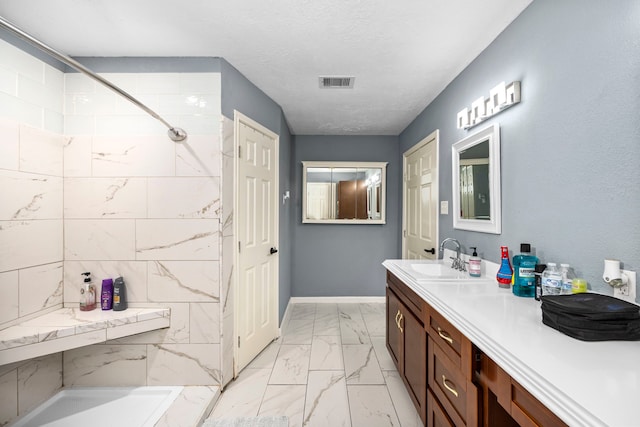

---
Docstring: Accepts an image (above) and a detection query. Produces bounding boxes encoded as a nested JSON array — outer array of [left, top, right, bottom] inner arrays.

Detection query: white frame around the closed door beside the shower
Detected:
[[231, 110, 280, 378]]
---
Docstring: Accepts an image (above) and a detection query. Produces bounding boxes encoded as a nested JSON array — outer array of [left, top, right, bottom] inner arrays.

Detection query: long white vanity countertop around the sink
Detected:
[[382, 260, 640, 427]]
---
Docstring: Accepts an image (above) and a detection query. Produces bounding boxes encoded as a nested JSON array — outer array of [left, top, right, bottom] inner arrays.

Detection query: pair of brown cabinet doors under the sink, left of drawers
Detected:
[[386, 273, 427, 422]]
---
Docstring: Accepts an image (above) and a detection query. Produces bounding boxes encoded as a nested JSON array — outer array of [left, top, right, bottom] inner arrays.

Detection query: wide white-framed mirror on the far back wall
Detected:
[[302, 162, 387, 224]]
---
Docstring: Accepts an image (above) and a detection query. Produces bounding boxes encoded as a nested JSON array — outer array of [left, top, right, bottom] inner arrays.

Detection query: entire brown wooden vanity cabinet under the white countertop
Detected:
[[386, 272, 566, 427]]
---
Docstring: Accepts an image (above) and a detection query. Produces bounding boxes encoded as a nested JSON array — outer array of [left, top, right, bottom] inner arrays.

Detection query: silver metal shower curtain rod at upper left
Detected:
[[0, 16, 187, 142]]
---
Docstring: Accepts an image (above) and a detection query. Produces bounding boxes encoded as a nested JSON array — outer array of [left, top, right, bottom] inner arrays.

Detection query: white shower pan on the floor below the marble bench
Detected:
[[11, 387, 183, 427]]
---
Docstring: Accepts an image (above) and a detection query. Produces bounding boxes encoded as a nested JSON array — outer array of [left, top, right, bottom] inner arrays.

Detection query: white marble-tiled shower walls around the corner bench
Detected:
[[0, 40, 232, 425]]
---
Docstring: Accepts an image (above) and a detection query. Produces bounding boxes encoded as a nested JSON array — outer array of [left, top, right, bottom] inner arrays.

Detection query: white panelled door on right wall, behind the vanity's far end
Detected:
[[402, 130, 438, 259]]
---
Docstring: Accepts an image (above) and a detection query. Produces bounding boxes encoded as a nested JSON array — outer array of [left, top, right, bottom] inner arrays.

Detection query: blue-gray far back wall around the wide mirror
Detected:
[[291, 135, 402, 297]]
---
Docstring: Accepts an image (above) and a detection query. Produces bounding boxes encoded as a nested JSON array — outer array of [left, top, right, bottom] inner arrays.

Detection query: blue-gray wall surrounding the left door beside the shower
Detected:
[[220, 59, 293, 320]]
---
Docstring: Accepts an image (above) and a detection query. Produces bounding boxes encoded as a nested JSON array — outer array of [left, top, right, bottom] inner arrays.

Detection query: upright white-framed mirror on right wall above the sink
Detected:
[[451, 124, 502, 234]]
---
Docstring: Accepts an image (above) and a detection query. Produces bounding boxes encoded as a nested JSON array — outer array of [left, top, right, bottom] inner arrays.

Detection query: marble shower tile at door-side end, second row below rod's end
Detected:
[[148, 177, 221, 218]]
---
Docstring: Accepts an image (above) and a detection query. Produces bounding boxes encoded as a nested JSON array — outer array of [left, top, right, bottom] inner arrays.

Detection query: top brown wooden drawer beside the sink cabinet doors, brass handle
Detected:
[[427, 310, 473, 379]]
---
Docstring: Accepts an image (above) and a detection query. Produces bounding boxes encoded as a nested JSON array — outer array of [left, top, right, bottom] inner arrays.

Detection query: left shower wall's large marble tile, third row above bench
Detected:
[[0, 170, 62, 221]]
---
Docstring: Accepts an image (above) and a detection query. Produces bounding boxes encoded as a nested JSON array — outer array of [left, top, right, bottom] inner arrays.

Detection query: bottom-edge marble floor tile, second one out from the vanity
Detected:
[[347, 385, 400, 427]]
